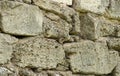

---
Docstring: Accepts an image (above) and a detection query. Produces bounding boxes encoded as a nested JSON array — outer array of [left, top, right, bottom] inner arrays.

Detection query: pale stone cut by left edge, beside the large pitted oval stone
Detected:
[[0, 33, 18, 64]]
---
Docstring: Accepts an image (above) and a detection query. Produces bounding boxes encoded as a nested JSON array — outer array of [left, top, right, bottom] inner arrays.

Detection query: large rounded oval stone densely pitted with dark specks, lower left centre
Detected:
[[13, 37, 65, 69]]
